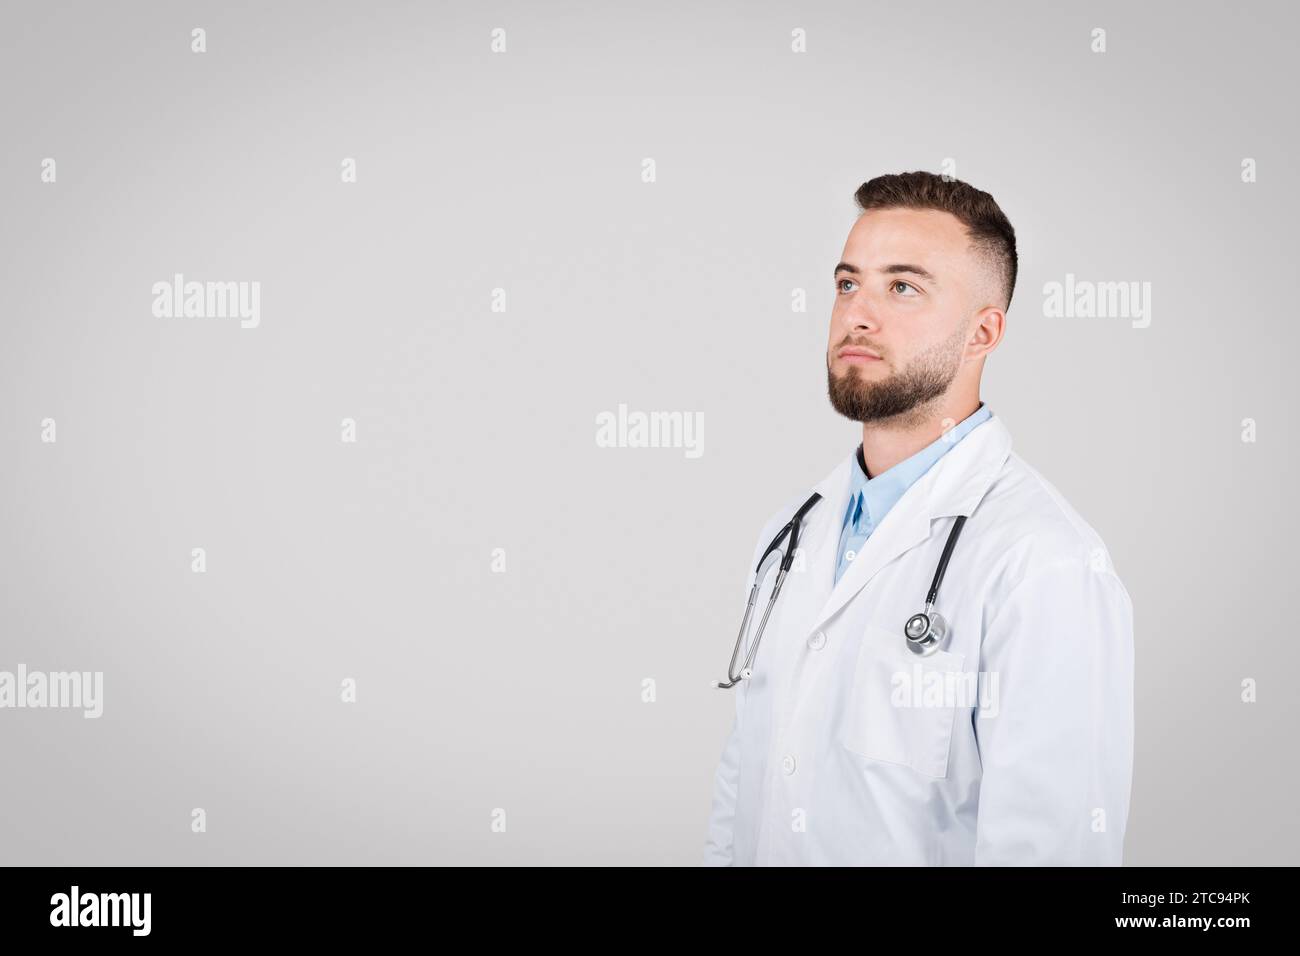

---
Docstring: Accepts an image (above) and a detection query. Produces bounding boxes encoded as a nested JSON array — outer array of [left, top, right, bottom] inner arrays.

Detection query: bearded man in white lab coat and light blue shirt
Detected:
[[705, 173, 1134, 865]]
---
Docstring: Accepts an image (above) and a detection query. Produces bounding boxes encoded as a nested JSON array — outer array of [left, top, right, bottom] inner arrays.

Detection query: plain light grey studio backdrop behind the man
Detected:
[[0, 3, 1300, 865]]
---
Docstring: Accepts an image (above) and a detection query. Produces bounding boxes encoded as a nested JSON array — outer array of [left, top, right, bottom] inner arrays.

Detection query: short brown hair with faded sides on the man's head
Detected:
[[854, 170, 1019, 310]]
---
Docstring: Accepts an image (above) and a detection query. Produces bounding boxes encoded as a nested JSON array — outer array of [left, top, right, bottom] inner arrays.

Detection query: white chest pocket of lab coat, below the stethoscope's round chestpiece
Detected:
[[840, 624, 965, 777]]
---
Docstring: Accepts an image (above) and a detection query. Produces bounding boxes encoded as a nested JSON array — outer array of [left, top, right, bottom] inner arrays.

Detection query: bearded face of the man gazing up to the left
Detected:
[[826, 208, 984, 421]]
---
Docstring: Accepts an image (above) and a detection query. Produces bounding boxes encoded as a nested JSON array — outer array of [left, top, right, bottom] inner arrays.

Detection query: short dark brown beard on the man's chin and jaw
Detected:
[[826, 321, 966, 421]]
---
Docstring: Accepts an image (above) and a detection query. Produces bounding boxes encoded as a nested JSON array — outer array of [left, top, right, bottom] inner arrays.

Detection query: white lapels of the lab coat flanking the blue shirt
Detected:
[[810, 415, 1011, 628]]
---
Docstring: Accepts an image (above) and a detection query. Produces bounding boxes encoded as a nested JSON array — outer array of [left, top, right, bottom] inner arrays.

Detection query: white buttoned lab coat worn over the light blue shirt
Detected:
[[705, 415, 1134, 865]]
